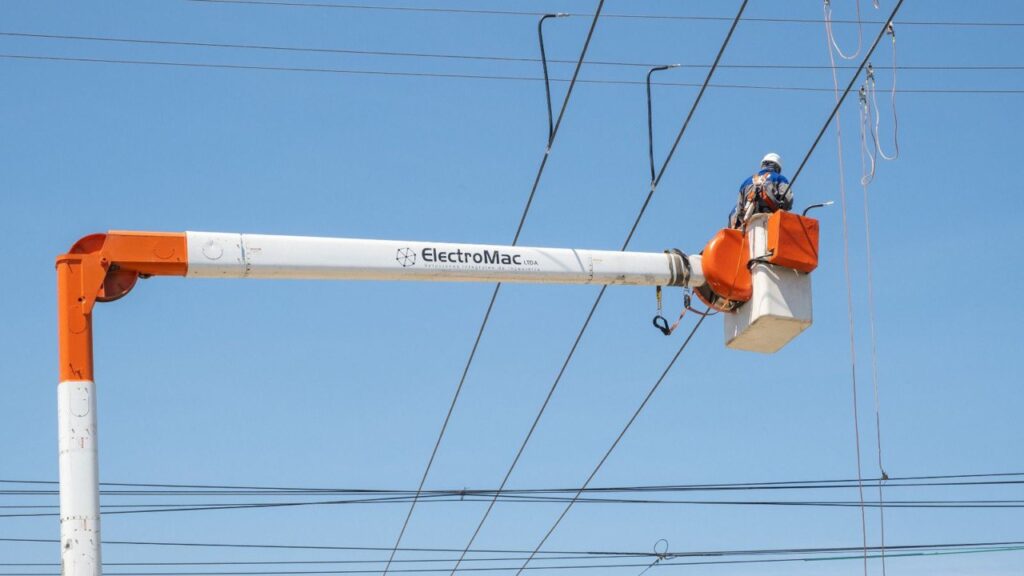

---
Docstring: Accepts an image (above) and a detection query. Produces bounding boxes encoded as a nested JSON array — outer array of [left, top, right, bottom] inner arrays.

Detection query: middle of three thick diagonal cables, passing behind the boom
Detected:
[[452, 5, 749, 576]]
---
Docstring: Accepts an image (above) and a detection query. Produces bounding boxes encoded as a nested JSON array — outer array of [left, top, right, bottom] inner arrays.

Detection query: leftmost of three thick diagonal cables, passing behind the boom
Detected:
[[384, 0, 604, 576]]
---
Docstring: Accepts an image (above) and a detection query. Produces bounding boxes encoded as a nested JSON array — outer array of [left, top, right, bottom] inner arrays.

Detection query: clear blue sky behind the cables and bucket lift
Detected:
[[0, 0, 1024, 576]]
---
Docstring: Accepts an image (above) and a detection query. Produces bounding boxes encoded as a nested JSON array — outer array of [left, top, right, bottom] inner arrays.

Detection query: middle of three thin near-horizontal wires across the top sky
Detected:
[[0, 31, 1024, 72]]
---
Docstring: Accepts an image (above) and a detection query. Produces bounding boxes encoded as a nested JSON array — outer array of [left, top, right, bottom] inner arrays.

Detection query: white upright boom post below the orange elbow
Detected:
[[57, 380, 102, 576]]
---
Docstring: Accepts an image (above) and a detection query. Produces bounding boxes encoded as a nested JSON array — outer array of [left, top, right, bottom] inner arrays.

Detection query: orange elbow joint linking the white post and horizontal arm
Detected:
[[56, 232, 188, 381]]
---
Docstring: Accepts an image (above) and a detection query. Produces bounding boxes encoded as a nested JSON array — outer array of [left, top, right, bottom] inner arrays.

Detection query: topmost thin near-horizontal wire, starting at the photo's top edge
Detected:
[[186, 0, 1024, 28]]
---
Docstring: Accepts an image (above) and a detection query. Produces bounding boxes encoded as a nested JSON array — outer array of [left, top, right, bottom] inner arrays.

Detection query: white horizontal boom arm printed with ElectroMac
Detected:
[[186, 232, 705, 287]]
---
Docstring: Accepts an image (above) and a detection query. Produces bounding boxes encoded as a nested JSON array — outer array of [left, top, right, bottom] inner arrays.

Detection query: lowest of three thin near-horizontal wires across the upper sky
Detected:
[[0, 53, 1024, 94]]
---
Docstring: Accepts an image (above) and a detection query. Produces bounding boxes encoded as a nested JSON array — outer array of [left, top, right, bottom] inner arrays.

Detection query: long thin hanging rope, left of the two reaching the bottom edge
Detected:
[[825, 10, 867, 576]]
